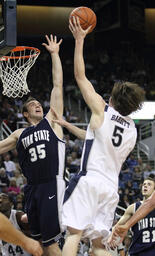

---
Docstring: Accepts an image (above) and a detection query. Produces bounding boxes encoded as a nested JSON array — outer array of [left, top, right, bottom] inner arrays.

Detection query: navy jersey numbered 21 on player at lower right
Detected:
[[129, 202, 155, 255]]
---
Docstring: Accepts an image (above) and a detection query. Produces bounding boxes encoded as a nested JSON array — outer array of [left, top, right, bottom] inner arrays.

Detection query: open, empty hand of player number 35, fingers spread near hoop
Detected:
[[42, 34, 62, 54]]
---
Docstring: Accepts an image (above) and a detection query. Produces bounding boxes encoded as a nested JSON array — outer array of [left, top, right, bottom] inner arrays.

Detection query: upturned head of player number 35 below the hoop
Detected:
[[22, 97, 43, 122]]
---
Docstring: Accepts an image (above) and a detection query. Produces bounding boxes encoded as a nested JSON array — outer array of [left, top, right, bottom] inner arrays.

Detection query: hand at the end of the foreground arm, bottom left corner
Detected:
[[22, 237, 43, 256]]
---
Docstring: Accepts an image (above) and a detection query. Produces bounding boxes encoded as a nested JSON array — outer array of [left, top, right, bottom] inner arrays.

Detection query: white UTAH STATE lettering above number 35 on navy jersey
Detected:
[[22, 130, 50, 149]]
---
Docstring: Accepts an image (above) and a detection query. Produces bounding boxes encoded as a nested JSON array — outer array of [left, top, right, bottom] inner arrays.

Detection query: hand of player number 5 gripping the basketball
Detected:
[[69, 16, 91, 40]]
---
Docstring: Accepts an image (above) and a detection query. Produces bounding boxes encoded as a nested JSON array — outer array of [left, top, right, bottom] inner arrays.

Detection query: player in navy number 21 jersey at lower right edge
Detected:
[[110, 177, 155, 256]]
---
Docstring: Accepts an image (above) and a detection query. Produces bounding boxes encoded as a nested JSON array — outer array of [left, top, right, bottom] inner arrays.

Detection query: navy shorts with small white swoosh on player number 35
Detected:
[[24, 180, 62, 246]]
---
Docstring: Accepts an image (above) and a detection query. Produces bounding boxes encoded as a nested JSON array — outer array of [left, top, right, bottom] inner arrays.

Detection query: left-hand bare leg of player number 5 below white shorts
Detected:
[[62, 227, 83, 256]]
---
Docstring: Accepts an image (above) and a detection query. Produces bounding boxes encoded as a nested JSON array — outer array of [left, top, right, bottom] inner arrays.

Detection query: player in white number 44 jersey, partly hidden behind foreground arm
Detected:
[[0, 193, 31, 256]]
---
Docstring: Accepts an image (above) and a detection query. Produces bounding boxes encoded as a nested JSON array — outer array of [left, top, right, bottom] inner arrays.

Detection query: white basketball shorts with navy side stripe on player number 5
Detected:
[[62, 175, 119, 243]]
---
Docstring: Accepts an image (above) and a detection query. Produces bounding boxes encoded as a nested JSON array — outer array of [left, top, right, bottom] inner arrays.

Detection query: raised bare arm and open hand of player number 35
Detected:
[[43, 35, 63, 119]]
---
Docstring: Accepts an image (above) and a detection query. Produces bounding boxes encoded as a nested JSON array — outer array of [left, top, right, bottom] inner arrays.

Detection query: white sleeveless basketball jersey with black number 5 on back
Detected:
[[81, 105, 137, 187]]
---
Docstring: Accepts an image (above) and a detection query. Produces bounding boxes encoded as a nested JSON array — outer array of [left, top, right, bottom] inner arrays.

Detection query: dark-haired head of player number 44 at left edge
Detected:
[[0, 193, 13, 217]]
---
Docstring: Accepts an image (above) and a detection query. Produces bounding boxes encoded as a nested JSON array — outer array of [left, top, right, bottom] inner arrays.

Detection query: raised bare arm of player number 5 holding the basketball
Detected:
[[69, 17, 105, 114]]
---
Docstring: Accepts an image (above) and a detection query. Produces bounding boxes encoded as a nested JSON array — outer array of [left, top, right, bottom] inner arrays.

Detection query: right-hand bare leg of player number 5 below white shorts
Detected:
[[92, 237, 111, 256]]
